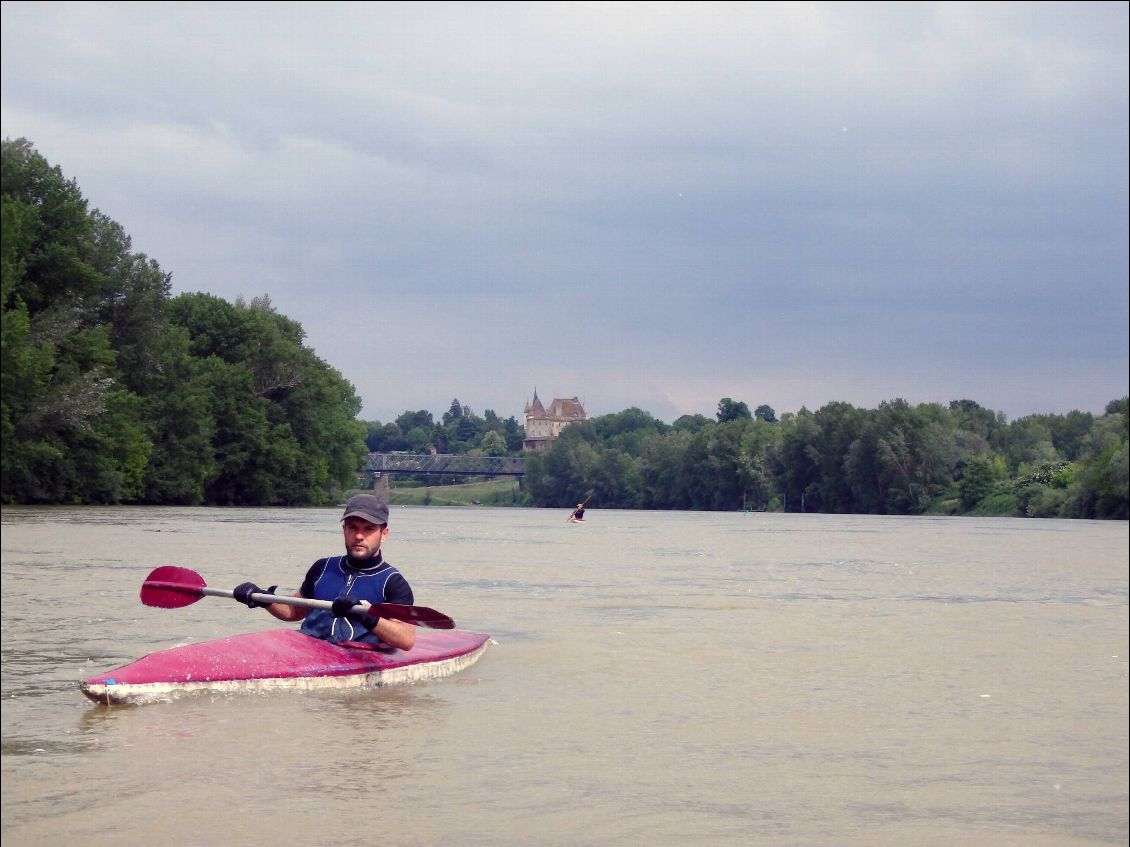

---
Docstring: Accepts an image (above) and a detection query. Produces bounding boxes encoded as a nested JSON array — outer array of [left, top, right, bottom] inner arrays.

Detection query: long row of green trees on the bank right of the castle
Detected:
[[523, 396, 1130, 519]]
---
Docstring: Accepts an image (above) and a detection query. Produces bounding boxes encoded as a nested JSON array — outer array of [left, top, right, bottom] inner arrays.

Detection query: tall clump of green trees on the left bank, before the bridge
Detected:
[[0, 139, 365, 506]]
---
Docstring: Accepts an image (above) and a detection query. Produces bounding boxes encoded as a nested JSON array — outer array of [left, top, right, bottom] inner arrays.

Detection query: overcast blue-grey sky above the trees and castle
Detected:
[[2, 1, 1130, 421]]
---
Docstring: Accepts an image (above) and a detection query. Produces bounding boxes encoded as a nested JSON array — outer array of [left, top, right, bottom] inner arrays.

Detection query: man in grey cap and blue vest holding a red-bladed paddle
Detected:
[[233, 495, 416, 650]]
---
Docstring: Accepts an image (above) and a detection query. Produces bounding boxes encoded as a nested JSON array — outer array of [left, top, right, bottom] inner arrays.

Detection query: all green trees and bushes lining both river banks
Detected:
[[0, 139, 1130, 519]]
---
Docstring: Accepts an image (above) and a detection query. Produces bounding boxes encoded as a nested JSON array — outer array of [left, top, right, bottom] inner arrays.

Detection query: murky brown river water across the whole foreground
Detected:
[[0, 507, 1130, 847]]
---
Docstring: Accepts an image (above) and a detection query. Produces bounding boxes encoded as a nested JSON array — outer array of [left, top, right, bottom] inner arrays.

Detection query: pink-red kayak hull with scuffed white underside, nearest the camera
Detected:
[[80, 629, 490, 705]]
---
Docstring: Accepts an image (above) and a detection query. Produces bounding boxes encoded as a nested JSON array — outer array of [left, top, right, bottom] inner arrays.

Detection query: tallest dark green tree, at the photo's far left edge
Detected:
[[0, 139, 149, 503]]
